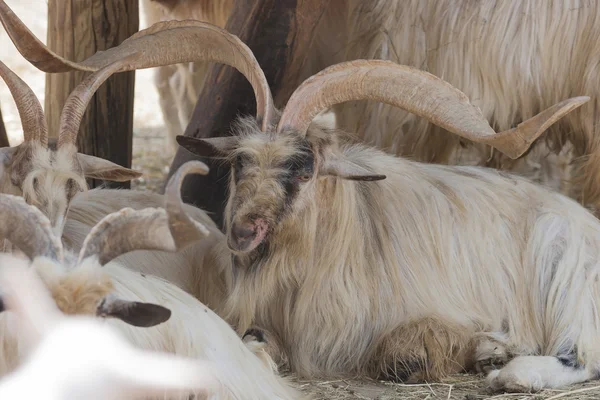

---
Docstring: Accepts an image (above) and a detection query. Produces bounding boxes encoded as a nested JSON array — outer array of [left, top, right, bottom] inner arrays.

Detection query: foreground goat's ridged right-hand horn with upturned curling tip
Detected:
[[79, 161, 209, 265]]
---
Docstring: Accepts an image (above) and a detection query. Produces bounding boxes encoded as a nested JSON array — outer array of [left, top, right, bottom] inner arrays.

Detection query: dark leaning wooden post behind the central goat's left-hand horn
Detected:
[[170, 0, 327, 227]]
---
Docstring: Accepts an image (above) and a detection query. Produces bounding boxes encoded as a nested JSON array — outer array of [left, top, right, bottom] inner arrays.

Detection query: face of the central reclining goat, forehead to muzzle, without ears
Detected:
[[227, 133, 315, 252]]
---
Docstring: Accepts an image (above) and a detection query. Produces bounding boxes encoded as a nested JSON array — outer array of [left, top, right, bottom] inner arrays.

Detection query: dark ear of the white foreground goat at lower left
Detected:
[[96, 296, 171, 328]]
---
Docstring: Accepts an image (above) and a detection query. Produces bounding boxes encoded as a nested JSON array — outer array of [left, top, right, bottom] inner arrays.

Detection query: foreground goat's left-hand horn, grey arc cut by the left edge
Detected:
[[0, 194, 63, 261]]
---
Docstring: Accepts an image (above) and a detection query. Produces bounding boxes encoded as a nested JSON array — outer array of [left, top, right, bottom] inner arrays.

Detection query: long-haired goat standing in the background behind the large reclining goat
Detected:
[[145, 0, 600, 209]]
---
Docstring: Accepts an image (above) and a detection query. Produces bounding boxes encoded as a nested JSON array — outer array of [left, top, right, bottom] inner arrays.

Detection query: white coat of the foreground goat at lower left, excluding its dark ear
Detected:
[[0, 257, 299, 399]]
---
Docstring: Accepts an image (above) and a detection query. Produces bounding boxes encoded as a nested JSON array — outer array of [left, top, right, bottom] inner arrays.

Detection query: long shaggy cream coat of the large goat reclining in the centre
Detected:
[[220, 120, 600, 390]]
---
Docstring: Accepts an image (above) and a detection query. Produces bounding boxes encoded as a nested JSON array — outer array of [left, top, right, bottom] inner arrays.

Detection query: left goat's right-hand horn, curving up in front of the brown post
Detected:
[[57, 53, 140, 148]]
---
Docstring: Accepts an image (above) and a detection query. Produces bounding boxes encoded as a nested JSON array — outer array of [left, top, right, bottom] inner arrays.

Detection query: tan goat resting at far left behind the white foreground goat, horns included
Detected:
[[0, 57, 231, 308]]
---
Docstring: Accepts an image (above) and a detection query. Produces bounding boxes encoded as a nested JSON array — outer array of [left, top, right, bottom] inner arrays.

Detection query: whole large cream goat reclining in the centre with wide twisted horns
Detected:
[[5, 6, 594, 385]]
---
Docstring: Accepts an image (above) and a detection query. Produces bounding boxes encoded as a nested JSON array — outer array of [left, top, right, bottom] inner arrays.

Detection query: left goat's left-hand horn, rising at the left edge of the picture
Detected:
[[0, 61, 48, 147]]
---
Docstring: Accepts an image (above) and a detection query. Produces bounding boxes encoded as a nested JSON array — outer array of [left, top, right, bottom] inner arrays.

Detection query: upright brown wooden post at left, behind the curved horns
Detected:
[[45, 0, 139, 188]]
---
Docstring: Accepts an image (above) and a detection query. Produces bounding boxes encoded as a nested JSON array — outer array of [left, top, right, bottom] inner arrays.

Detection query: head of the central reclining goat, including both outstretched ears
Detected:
[[177, 118, 385, 253]]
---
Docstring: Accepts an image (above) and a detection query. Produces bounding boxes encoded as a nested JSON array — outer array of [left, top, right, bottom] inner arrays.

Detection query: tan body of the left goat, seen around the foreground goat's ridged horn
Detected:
[[63, 189, 230, 310]]
